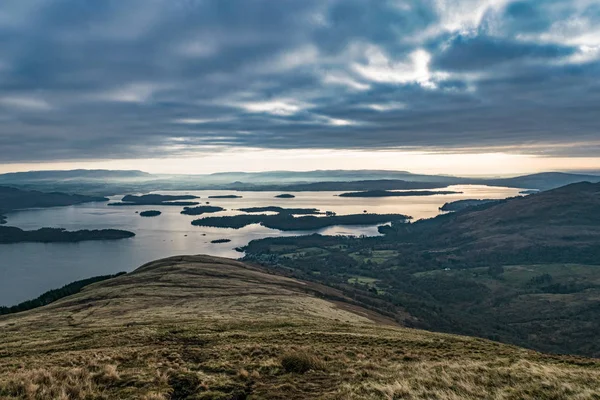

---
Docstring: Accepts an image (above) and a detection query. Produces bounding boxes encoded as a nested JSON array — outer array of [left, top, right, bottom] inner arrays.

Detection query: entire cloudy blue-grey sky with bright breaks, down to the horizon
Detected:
[[0, 0, 600, 175]]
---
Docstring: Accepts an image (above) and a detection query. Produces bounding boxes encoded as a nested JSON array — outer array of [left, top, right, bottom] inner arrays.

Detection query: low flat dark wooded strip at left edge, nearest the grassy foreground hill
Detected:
[[0, 226, 135, 243]]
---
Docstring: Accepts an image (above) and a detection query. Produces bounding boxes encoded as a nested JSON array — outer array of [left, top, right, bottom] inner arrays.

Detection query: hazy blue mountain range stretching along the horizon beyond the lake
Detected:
[[0, 170, 600, 195]]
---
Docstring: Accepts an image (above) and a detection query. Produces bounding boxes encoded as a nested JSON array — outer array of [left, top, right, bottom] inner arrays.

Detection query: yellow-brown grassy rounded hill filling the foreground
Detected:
[[0, 256, 600, 400]]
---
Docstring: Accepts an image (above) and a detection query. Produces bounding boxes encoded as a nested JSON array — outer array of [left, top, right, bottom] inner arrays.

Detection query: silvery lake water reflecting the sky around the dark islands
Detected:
[[0, 186, 519, 305]]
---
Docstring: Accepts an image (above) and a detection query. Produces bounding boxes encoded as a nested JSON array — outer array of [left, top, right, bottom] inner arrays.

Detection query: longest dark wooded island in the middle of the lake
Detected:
[[192, 214, 411, 231]]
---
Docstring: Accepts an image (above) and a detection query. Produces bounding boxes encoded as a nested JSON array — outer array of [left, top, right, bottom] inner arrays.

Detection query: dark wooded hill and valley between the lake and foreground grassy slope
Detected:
[[244, 183, 600, 357]]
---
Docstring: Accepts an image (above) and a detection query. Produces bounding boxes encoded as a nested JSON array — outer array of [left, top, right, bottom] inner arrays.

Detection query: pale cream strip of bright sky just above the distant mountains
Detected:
[[0, 150, 600, 176]]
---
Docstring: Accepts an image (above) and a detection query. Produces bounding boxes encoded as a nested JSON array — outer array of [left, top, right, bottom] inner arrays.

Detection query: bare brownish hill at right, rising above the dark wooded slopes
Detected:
[[411, 182, 600, 261]]
